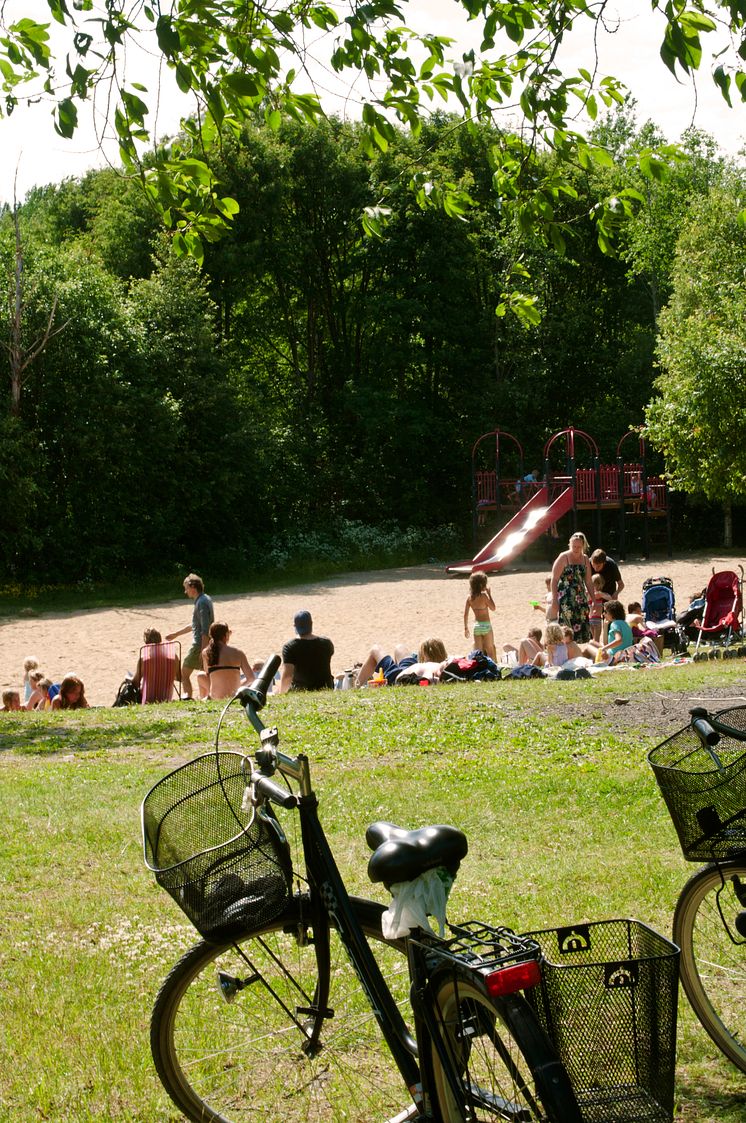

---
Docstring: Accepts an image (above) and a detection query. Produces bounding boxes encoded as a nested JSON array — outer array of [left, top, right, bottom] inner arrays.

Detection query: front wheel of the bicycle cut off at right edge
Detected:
[[673, 858, 746, 1072]]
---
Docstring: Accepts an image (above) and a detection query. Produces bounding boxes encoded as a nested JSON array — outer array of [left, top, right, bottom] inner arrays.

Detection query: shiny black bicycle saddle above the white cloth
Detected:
[[365, 822, 468, 888]]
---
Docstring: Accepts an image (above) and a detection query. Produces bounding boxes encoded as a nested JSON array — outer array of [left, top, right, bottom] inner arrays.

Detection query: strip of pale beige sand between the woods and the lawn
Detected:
[[0, 555, 743, 705]]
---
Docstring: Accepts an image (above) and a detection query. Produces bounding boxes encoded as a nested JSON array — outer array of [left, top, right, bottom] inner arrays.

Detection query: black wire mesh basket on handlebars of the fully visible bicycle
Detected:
[[143, 752, 292, 940]]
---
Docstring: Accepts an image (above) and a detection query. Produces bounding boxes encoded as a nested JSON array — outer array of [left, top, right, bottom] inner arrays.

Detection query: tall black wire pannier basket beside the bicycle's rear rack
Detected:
[[526, 920, 679, 1123]]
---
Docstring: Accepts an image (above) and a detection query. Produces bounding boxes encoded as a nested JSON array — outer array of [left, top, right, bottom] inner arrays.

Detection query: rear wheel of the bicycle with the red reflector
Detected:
[[431, 969, 582, 1123]]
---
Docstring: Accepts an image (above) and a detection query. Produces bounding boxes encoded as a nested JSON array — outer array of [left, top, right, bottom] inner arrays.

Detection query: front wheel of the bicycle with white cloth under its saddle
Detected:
[[151, 898, 410, 1123]]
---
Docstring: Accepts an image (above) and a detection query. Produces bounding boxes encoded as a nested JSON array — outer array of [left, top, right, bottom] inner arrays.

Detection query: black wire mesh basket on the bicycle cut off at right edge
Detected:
[[648, 706, 746, 861]]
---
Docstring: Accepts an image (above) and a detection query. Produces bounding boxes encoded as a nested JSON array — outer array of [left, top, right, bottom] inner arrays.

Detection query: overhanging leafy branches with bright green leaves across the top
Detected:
[[0, 0, 746, 274]]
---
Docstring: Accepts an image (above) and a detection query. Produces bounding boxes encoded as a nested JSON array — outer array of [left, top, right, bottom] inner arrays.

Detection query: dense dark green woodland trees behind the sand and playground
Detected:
[[0, 111, 740, 581]]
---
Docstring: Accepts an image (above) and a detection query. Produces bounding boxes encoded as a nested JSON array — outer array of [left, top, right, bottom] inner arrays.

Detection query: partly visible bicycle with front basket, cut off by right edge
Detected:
[[648, 706, 746, 1072]]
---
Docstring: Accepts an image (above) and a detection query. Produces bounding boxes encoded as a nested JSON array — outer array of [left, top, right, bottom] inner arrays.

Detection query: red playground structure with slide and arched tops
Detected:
[[447, 427, 671, 574]]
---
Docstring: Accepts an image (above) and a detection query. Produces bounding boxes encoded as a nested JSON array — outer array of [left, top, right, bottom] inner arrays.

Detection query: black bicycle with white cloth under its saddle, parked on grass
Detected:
[[143, 656, 581, 1123]]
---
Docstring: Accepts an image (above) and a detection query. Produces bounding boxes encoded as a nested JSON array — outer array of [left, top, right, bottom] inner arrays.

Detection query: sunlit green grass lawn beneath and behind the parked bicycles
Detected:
[[0, 660, 746, 1123]]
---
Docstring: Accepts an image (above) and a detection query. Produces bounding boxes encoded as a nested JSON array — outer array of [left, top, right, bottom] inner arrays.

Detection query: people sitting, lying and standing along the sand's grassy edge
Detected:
[[1, 531, 692, 712]]
